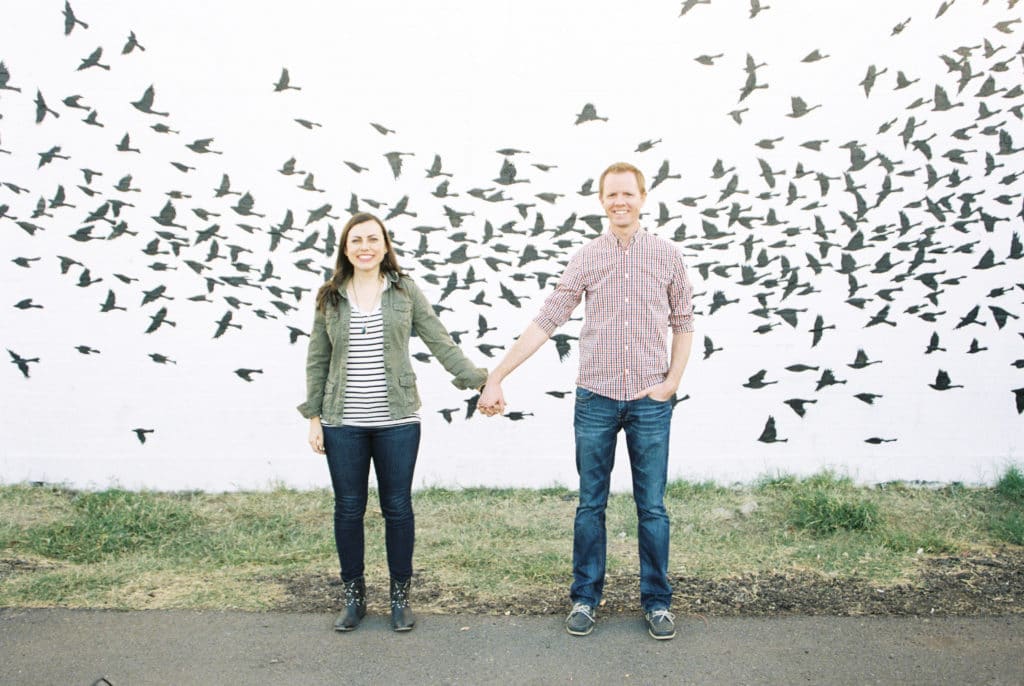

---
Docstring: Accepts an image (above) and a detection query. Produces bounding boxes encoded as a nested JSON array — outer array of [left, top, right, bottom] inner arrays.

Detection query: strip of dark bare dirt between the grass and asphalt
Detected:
[[274, 548, 1024, 616]]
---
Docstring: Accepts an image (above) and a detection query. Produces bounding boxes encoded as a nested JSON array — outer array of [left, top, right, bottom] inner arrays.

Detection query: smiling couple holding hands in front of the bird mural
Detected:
[[299, 163, 693, 640]]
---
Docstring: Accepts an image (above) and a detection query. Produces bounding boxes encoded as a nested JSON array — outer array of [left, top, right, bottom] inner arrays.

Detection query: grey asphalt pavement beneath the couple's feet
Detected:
[[0, 608, 1024, 686]]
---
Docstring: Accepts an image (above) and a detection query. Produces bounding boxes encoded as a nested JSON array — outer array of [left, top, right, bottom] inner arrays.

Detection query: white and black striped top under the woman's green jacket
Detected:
[[329, 303, 420, 426]]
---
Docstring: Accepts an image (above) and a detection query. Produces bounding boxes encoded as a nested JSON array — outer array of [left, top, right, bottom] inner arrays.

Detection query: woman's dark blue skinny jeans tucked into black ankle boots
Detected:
[[324, 422, 420, 582]]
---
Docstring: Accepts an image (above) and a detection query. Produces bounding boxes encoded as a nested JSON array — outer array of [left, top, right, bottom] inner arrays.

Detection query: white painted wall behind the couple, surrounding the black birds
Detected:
[[0, 0, 1024, 489]]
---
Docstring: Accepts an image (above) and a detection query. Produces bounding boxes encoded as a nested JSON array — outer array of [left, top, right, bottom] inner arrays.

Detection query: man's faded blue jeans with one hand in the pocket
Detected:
[[569, 388, 672, 612]]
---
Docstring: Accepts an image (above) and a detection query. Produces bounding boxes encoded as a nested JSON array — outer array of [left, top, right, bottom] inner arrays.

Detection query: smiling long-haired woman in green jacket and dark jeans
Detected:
[[299, 213, 487, 631]]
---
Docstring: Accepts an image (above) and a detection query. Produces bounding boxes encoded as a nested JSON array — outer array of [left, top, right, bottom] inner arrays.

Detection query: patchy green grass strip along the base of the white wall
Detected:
[[0, 467, 1024, 611]]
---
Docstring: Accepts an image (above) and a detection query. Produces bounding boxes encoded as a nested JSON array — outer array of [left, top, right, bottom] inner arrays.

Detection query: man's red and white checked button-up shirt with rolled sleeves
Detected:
[[534, 229, 693, 400]]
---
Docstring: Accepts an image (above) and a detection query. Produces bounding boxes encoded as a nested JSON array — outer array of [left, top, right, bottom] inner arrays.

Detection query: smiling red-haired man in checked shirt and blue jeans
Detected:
[[477, 163, 693, 639]]
